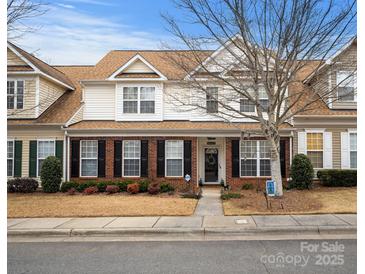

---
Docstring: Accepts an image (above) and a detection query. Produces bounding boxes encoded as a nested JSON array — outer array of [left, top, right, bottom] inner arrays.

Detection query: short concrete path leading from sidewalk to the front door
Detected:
[[194, 187, 223, 216]]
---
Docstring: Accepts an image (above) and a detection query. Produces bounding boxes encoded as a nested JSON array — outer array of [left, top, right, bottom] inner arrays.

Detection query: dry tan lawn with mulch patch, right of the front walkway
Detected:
[[223, 187, 356, 216]]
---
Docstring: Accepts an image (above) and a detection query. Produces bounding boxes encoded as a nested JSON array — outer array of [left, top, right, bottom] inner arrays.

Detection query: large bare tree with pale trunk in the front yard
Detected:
[[163, 0, 356, 196]]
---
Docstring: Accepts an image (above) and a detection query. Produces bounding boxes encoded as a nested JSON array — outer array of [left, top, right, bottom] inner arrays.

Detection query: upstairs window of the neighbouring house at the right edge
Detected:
[[336, 71, 356, 102]]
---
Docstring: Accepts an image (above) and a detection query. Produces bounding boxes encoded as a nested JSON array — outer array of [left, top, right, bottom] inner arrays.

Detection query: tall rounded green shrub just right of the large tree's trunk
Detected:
[[289, 154, 314, 189]]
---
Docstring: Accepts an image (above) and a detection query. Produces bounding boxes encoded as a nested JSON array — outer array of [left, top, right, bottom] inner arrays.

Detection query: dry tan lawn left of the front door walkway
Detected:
[[8, 193, 197, 218]]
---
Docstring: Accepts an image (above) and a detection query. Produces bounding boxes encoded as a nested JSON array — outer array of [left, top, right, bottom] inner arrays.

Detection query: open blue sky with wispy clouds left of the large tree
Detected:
[[15, 0, 185, 64]]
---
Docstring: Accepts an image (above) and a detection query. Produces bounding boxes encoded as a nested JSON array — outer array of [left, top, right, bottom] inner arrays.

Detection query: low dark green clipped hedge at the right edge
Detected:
[[317, 169, 357, 187]]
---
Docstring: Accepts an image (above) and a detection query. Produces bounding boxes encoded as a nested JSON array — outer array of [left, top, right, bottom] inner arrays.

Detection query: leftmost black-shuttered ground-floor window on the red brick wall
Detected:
[[80, 140, 98, 177]]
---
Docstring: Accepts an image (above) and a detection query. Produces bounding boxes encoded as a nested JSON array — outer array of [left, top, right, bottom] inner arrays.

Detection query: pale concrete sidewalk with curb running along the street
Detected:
[[8, 214, 357, 237]]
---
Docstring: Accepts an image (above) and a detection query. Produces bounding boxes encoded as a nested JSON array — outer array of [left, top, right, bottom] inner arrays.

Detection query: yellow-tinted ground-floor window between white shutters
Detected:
[[307, 133, 323, 168]]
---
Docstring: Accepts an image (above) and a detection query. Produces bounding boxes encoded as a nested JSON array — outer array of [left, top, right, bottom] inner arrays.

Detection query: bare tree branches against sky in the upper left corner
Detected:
[[7, 0, 47, 39]]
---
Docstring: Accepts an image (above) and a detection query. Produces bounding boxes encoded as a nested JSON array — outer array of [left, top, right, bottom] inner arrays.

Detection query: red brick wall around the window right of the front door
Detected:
[[226, 137, 290, 190]]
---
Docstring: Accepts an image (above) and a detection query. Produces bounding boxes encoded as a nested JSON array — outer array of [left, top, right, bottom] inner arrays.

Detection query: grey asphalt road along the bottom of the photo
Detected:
[[8, 240, 357, 274]]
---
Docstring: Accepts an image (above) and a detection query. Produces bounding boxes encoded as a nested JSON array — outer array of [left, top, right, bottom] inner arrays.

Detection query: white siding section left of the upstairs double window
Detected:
[[83, 85, 115, 120]]
